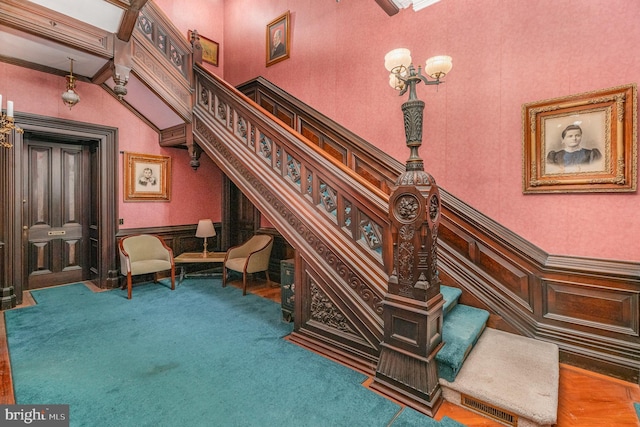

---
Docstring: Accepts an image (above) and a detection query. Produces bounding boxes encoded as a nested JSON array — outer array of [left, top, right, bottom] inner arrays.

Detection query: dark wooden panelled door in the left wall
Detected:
[[23, 141, 91, 289]]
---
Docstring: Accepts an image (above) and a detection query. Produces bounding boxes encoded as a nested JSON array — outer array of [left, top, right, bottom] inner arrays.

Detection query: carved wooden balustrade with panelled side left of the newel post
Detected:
[[193, 66, 392, 370]]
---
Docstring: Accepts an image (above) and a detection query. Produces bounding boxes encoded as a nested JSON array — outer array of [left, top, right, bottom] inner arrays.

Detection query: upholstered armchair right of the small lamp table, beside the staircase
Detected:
[[222, 234, 273, 295]]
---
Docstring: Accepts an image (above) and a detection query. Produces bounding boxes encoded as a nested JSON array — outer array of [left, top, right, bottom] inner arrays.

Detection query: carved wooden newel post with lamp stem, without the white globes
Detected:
[[371, 49, 450, 416]]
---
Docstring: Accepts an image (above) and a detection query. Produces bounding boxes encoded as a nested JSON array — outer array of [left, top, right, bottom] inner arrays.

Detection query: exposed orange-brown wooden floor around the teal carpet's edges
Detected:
[[0, 280, 640, 427]]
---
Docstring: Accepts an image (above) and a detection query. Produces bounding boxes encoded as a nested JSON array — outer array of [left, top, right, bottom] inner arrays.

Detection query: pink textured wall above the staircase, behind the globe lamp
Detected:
[[223, 0, 640, 261]]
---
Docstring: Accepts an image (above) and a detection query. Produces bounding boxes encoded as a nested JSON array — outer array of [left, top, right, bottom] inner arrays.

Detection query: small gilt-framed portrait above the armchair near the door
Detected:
[[124, 152, 171, 202]]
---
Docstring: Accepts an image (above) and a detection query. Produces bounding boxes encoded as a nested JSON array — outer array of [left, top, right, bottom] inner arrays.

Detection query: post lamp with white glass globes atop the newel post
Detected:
[[384, 48, 453, 170]]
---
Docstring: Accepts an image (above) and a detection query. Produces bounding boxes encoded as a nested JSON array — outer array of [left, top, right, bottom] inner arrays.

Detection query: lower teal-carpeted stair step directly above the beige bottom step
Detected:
[[436, 304, 489, 381]]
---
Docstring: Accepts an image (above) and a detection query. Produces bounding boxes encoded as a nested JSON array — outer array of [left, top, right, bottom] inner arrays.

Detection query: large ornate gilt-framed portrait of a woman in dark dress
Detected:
[[522, 84, 638, 194]]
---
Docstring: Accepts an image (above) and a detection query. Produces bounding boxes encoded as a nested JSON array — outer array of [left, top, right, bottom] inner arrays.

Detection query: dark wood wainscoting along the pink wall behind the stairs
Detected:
[[239, 78, 640, 384]]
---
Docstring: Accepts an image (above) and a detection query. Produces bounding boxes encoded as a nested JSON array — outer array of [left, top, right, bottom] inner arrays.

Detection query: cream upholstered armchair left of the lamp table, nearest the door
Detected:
[[118, 234, 176, 299]]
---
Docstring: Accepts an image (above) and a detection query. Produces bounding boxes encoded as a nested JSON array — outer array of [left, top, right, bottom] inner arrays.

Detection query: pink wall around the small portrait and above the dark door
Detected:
[[0, 62, 222, 228]]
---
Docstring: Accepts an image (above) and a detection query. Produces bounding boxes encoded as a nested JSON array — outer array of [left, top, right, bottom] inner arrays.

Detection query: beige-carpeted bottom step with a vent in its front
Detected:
[[440, 328, 560, 426]]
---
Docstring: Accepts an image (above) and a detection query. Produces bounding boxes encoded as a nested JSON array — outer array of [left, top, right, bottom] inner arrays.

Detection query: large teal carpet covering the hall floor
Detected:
[[4, 279, 459, 427]]
